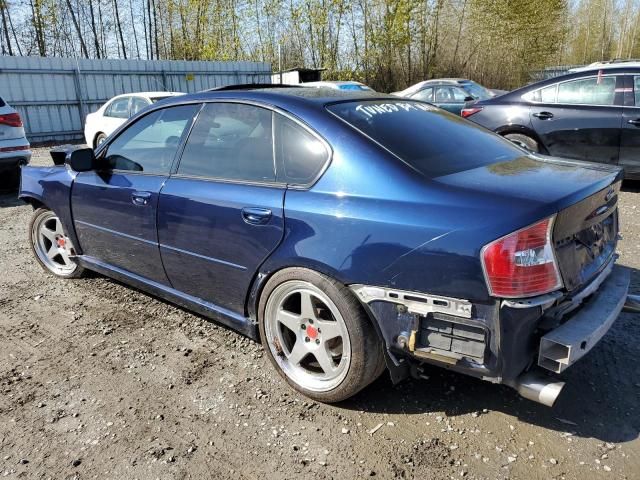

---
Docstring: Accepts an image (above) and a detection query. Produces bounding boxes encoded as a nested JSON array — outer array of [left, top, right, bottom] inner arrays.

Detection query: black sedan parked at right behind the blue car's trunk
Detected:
[[462, 64, 640, 178]]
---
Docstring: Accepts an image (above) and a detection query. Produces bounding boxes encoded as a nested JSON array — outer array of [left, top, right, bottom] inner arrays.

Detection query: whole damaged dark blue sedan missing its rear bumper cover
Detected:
[[20, 87, 629, 405]]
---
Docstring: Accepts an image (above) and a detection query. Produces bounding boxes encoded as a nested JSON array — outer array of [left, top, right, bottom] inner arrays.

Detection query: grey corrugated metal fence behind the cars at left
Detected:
[[0, 56, 271, 143]]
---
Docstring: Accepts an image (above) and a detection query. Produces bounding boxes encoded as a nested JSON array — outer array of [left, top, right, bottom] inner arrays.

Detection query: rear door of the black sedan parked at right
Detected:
[[530, 75, 622, 164]]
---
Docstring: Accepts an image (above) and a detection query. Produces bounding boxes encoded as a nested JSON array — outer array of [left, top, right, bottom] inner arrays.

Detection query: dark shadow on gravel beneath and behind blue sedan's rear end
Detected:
[[337, 269, 640, 443]]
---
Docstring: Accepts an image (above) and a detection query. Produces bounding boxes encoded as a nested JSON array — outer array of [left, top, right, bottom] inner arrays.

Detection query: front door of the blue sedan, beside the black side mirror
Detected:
[[71, 105, 199, 284]]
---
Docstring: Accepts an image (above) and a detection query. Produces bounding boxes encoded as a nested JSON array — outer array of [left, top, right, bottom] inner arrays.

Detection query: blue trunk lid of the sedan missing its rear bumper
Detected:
[[434, 156, 622, 293]]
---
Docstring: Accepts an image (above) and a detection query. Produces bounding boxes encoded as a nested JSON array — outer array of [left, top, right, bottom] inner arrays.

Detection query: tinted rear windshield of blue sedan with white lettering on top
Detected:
[[327, 100, 523, 177]]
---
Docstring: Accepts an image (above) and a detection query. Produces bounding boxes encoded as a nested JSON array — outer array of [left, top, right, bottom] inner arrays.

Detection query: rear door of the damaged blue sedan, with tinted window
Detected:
[[158, 102, 285, 314]]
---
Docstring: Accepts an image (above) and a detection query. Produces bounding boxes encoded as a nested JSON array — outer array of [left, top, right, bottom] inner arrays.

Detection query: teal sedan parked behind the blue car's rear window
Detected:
[[392, 78, 504, 115]]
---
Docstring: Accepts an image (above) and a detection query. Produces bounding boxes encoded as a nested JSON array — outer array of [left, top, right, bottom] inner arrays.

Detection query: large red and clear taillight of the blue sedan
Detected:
[[481, 217, 562, 298]]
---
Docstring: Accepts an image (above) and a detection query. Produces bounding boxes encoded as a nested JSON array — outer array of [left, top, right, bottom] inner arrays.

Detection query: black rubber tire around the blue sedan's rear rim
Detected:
[[258, 267, 386, 403]]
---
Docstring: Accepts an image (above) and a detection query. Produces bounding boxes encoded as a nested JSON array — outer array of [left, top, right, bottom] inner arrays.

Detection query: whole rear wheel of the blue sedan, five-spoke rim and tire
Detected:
[[259, 268, 384, 403]]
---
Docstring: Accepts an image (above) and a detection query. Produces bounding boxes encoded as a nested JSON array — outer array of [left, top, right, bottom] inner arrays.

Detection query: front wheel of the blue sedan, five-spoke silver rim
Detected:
[[29, 208, 84, 278]]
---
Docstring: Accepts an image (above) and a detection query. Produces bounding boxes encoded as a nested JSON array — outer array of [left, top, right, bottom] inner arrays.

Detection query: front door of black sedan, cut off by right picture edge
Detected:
[[618, 75, 640, 177]]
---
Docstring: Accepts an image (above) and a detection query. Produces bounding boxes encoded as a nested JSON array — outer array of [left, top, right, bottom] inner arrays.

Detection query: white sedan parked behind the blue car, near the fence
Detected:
[[84, 92, 184, 148]]
